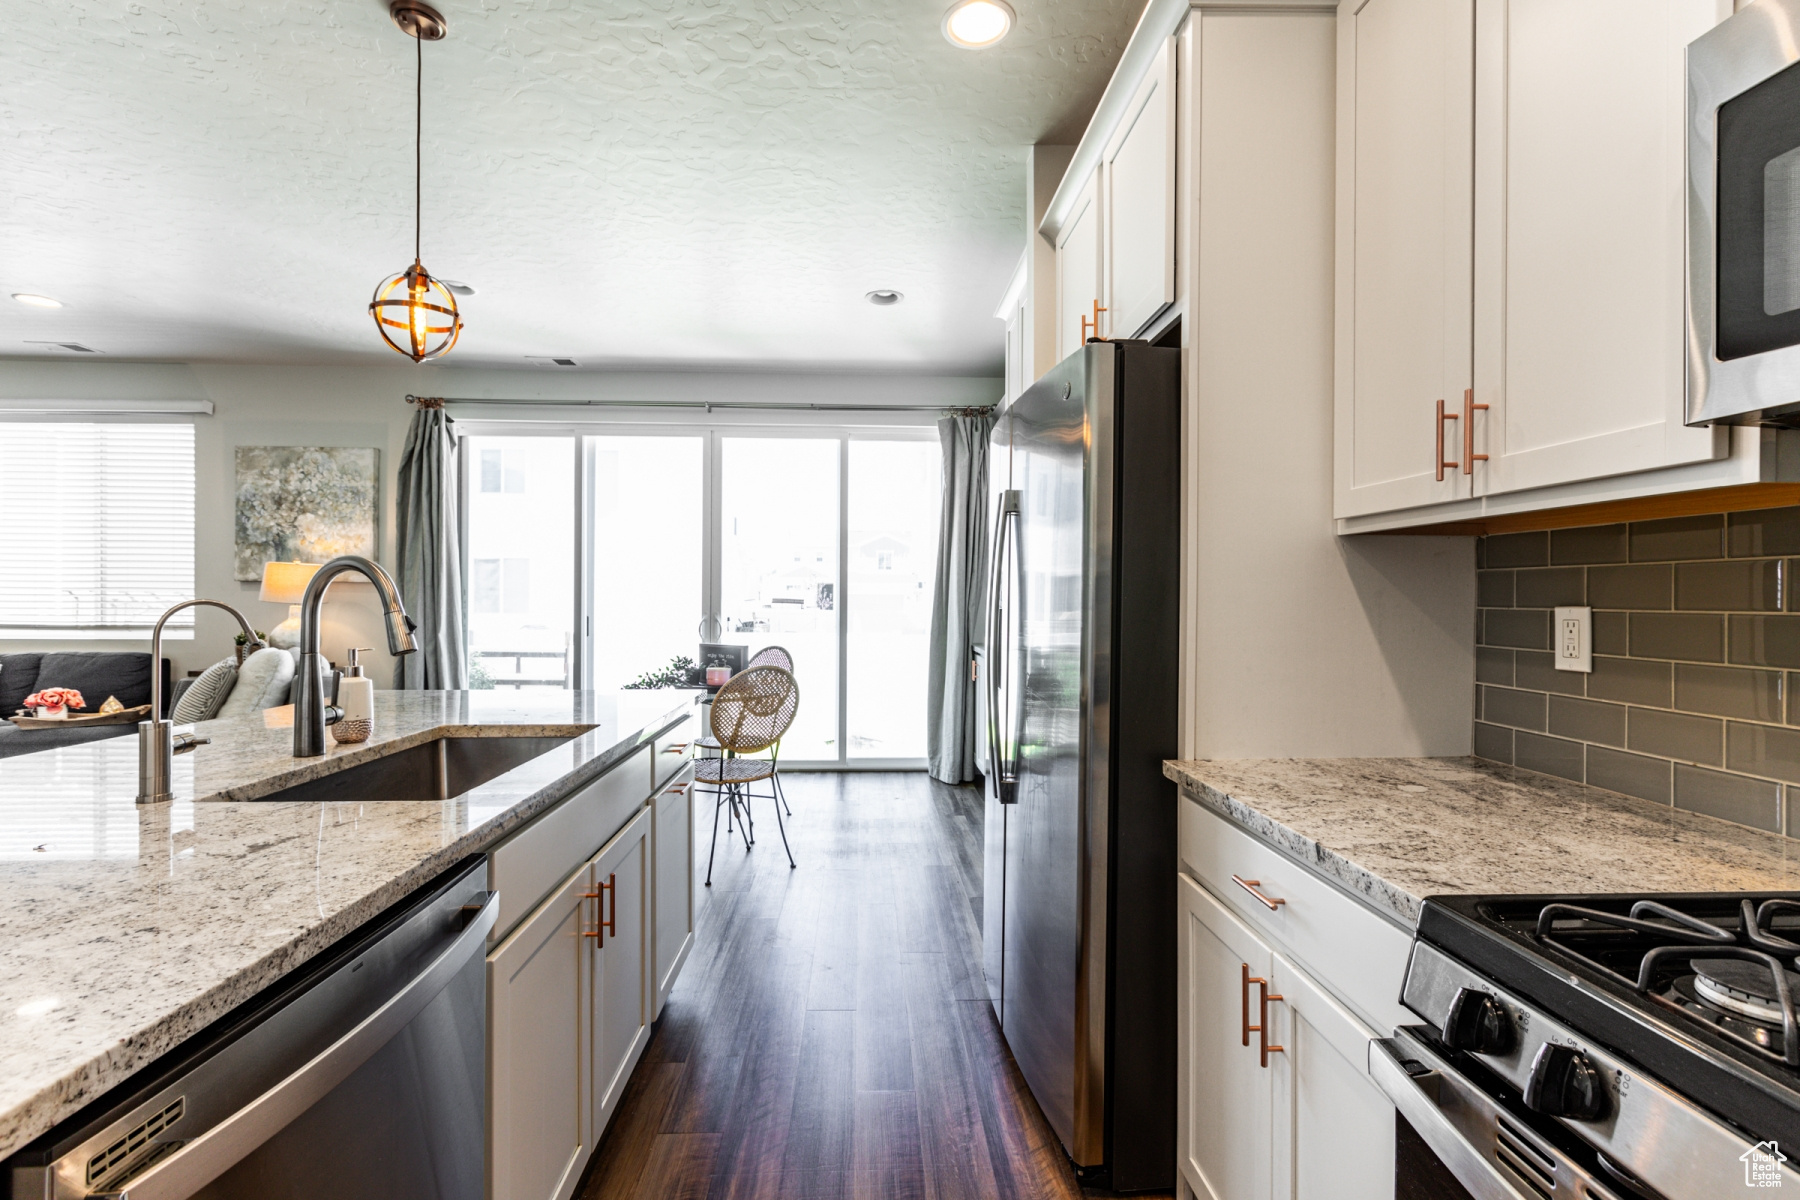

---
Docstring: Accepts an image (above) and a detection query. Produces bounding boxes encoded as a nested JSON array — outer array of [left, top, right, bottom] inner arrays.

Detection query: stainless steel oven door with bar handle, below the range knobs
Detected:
[[1368, 1027, 1641, 1200]]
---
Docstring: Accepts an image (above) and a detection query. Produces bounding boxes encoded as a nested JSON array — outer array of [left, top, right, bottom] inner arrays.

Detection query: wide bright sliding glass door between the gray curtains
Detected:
[[463, 423, 941, 766]]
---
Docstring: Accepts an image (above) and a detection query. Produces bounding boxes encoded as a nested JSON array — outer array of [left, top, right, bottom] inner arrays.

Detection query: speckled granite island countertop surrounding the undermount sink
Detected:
[[0, 691, 693, 1157]]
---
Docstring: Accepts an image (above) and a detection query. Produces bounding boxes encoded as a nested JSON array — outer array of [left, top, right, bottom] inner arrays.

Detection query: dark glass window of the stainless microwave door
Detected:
[[1715, 63, 1800, 360]]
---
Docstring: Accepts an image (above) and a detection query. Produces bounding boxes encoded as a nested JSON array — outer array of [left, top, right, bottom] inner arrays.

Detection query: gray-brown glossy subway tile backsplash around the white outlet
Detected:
[[1474, 507, 1800, 837]]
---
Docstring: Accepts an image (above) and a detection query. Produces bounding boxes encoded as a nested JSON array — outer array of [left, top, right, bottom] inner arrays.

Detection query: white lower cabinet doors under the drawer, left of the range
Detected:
[[1177, 874, 1395, 1200]]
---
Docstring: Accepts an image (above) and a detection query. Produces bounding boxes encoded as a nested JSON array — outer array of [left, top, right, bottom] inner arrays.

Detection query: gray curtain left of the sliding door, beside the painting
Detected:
[[394, 398, 468, 689]]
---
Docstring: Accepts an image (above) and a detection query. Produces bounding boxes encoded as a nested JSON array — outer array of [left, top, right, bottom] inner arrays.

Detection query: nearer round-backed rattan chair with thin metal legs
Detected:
[[693, 666, 799, 887]]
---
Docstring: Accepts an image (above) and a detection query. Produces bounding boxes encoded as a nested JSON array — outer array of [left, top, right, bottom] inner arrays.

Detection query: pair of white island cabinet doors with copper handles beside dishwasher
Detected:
[[488, 808, 652, 1200]]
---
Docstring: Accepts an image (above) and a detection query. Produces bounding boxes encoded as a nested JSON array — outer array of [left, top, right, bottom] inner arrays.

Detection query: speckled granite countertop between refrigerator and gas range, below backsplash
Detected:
[[1163, 757, 1800, 927]]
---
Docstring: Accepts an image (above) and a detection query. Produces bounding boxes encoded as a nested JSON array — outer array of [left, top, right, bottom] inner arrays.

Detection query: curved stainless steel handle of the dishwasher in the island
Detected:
[[90, 892, 500, 1200]]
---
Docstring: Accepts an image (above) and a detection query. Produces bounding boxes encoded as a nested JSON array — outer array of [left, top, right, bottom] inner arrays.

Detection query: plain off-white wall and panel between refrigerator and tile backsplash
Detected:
[[1179, 9, 1474, 757]]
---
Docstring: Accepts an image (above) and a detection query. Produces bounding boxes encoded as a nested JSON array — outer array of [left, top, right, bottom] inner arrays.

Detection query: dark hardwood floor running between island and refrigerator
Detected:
[[576, 774, 1166, 1200]]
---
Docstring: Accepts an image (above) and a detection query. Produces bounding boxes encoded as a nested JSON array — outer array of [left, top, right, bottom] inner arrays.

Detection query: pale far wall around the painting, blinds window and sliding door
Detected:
[[0, 360, 1001, 687]]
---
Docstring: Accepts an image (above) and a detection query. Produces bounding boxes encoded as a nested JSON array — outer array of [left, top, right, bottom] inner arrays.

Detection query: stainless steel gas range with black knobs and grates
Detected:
[[1370, 894, 1800, 1200]]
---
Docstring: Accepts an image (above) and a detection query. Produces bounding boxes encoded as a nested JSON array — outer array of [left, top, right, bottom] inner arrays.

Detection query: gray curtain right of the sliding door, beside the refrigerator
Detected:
[[925, 414, 994, 783]]
